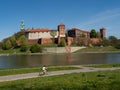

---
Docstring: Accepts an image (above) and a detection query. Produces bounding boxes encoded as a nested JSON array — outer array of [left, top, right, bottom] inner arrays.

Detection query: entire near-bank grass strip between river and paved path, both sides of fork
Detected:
[[0, 64, 120, 76]]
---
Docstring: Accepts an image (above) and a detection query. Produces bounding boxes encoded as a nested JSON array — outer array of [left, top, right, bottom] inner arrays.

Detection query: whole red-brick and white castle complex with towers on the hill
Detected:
[[21, 22, 105, 45]]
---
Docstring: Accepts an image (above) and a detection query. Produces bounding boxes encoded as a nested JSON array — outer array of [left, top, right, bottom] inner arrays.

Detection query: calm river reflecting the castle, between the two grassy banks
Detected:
[[0, 53, 120, 68]]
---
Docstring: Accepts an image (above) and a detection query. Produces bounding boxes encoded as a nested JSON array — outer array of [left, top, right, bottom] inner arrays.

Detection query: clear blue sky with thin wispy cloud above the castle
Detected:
[[0, 0, 120, 41]]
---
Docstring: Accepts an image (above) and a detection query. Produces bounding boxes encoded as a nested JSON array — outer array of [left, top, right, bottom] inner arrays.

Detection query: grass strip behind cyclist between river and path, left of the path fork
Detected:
[[0, 66, 80, 76]]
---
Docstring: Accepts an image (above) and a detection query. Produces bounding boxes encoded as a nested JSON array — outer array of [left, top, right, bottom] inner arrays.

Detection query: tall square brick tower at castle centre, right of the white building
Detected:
[[58, 24, 65, 44]]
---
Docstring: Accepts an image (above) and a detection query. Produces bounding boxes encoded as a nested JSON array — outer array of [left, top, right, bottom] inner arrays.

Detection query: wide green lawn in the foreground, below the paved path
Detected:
[[0, 70, 120, 90]]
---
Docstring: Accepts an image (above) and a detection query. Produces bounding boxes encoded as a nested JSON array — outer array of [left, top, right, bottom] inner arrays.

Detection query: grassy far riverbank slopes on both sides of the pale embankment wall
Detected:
[[0, 46, 120, 55]]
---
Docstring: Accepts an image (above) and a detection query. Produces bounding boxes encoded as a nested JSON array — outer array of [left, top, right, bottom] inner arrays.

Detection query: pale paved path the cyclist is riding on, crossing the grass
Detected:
[[0, 66, 120, 82]]
